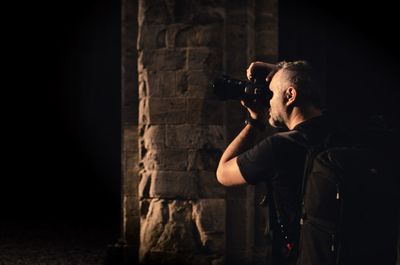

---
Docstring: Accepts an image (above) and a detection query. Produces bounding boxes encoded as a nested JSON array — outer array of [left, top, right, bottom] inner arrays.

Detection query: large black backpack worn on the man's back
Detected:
[[298, 127, 399, 265]]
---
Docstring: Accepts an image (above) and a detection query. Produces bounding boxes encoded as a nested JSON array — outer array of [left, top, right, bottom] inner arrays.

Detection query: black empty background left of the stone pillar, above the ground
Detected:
[[0, 0, 121, 227]]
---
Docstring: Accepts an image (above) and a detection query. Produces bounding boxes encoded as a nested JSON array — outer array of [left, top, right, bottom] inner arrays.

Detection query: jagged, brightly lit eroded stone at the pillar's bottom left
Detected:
[[140, 200, 219, 265]]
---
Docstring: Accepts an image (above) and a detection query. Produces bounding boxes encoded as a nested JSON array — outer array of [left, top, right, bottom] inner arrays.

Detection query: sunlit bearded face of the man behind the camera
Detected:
[[268, 70, 286, 128]]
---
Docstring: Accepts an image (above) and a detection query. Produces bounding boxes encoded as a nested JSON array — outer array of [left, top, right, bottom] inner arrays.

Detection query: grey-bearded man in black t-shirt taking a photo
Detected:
[[217, 61, 333, 265]]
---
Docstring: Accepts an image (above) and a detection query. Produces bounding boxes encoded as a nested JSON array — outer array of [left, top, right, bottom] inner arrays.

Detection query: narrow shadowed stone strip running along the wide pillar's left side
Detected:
[[118, 0, 140, 263]]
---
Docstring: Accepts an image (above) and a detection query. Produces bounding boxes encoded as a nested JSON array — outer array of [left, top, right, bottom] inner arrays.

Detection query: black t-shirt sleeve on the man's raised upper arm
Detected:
[[237, 137, 276, 184]]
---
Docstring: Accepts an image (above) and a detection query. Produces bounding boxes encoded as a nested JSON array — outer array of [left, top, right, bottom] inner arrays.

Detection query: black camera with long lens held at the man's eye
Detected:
[[212, 71, 272, 104]]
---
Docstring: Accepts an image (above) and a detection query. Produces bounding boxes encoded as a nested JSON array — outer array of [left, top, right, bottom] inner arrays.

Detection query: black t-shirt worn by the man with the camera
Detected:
[[237, 115, 336, 264]]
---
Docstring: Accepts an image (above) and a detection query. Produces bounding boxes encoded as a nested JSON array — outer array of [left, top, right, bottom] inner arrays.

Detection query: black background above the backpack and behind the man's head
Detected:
[[279, 0, 400, 128]]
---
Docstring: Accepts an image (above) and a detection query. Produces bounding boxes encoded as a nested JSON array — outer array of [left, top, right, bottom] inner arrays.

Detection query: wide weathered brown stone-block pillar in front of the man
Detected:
[[138, 0, 226, 264]]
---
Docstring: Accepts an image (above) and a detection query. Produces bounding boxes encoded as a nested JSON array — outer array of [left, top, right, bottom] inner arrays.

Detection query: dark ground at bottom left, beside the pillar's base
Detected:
[[0, 219, 116, 265]]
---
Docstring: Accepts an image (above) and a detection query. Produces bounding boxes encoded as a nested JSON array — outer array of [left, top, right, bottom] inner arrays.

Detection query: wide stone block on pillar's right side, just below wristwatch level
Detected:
[[166, 124, 225, 150]]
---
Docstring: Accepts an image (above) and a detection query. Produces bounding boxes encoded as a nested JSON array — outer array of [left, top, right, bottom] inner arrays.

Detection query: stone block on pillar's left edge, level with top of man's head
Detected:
[[138, 49, 186, 72]]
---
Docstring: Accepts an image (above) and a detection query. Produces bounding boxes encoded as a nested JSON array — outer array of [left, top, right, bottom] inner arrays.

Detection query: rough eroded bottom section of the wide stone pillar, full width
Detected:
[[140, 199, 225, 265]]
